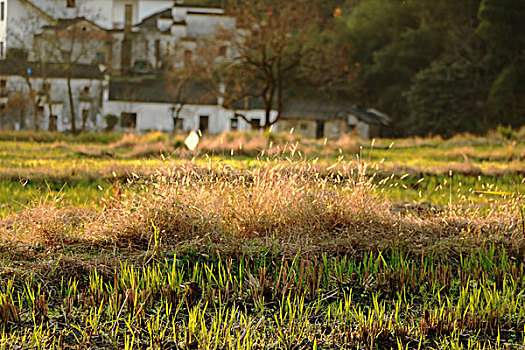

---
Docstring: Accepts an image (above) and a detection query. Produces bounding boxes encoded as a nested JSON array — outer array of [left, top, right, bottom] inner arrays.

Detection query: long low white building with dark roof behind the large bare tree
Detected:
[[103, 80, 276, 134]]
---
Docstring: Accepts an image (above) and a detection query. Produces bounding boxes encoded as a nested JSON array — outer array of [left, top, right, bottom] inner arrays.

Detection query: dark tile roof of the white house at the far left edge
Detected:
[[0, 59, 104, 80]]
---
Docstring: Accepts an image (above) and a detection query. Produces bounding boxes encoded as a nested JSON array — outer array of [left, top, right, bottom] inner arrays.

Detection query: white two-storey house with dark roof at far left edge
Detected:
[[0, 60, 107, 131]]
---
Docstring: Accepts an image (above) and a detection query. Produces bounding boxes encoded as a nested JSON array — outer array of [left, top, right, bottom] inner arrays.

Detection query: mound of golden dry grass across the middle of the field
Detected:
[[0, 162, 523, 255]]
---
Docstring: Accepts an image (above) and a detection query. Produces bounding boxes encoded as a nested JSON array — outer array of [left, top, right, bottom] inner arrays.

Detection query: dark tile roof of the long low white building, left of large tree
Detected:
[[109, 78, 217, 105]]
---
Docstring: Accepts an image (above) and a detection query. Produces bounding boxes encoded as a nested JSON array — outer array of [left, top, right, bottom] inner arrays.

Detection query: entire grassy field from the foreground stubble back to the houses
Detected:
[[0, 130, 525, 349]]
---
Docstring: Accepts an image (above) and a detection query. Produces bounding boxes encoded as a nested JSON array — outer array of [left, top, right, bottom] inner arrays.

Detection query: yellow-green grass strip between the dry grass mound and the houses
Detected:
[[0, 133, 525, 214]]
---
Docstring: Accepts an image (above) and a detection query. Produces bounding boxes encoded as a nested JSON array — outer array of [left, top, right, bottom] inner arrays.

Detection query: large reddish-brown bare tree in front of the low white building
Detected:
[[208, 0, 350, 128]]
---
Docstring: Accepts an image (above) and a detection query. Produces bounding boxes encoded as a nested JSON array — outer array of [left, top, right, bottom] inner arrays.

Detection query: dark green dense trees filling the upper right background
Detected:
[[335, 0, 525, 136]]
